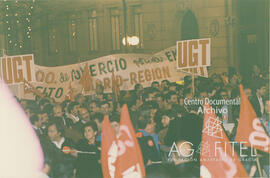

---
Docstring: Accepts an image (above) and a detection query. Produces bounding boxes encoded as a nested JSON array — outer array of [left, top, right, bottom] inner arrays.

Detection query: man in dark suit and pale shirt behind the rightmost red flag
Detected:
[[251, 80, 266, 117]]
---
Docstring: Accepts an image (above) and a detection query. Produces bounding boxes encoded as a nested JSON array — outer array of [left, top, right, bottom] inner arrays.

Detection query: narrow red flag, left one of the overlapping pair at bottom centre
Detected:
[[101, 116, 117, 178]]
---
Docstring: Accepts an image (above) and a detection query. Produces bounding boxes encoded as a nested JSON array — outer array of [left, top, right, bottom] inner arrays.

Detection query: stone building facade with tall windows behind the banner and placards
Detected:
[[0, 0, 269, 74]]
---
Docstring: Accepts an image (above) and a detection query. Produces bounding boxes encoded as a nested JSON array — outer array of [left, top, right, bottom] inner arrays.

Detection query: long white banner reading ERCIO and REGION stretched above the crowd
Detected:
[[11, 46, 207, 101]]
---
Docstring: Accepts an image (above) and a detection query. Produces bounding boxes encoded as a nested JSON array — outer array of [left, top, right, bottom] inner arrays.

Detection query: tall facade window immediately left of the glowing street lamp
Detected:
[[110, 8, 120, 50]]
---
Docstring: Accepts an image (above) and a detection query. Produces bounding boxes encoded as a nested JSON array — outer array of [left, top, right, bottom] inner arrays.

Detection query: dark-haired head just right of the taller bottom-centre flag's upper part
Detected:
[[137, 110, 155, 135]]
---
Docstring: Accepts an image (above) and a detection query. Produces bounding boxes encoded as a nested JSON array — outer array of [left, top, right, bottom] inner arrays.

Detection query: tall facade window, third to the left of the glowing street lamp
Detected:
[[68, 16, 77, 52]]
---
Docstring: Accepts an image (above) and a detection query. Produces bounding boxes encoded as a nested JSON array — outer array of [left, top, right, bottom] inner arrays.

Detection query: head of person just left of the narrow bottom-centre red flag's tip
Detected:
[[83, 121, 98, 144]]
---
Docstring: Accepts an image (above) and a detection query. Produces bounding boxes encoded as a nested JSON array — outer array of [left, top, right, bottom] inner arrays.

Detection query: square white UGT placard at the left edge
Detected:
[[0, 54, 35, 85]]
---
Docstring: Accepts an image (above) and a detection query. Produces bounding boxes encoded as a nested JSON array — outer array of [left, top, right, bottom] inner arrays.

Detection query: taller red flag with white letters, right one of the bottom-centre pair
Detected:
[[115, 104, 145, 178]]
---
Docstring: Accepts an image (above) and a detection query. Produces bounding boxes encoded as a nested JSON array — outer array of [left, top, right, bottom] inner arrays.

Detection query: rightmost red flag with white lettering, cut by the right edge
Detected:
[[235, 85, 270, 153]]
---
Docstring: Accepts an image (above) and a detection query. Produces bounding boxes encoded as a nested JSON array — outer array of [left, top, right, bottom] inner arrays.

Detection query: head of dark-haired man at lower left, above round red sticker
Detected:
[[47, 118, 64, 142]]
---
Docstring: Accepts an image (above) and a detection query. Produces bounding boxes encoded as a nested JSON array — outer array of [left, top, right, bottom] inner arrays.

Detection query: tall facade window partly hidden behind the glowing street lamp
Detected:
[[133, 6, 143, 48]]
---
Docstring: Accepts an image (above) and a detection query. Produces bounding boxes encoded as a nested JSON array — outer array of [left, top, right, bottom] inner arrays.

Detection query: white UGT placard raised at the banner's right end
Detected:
[[176, 38, 211, 69]]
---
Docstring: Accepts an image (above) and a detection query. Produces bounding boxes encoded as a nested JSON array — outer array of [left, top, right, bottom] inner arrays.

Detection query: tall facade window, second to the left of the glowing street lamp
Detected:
[[88, 10, 98, 51]]
